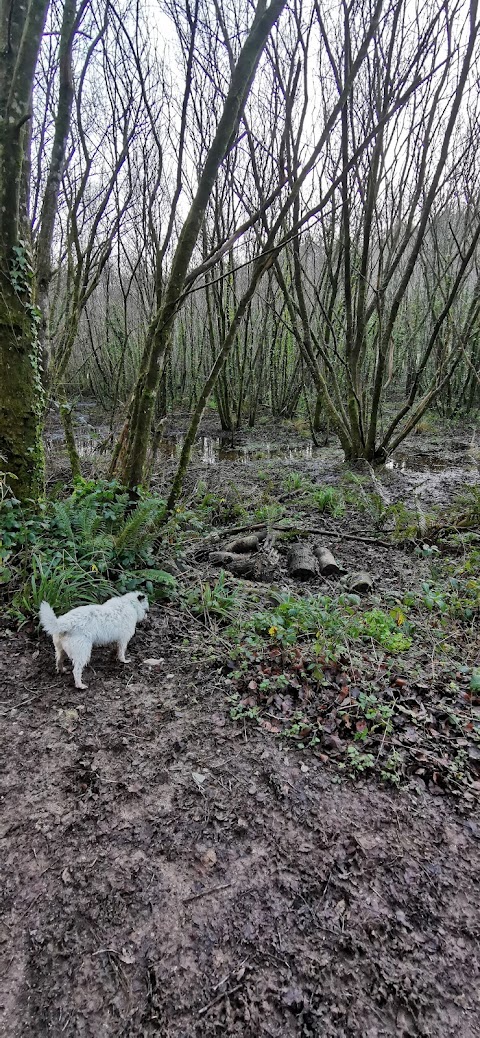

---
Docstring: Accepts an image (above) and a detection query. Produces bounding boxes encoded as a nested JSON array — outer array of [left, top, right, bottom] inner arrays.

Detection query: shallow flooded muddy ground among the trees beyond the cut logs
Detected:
[[46, 404, 480, 503]]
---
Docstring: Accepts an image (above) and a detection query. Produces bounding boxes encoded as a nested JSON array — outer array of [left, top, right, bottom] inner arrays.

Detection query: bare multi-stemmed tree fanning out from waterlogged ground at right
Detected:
[[288, 2, 479, 461]]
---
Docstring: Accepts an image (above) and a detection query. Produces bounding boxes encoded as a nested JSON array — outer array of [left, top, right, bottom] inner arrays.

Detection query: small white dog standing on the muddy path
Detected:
[[39, 591, 149, 688]]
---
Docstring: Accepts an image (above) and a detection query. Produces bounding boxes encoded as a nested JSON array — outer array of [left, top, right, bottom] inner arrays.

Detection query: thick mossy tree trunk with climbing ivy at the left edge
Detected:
[[0, 0, 49, 500]]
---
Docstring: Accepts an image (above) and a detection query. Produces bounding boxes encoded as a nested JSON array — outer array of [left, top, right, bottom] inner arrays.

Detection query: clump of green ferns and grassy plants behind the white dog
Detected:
[[0, 480, 176, 621]]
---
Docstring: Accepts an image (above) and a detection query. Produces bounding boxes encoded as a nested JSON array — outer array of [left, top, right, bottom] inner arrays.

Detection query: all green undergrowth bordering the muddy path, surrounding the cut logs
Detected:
[[0, 462, 480, 795]]
